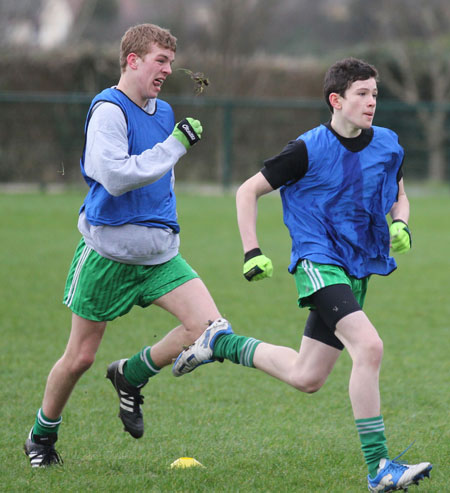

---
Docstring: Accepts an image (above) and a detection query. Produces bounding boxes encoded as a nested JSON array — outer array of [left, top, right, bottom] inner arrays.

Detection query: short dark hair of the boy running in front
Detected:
[[323, 57, 378, 113]]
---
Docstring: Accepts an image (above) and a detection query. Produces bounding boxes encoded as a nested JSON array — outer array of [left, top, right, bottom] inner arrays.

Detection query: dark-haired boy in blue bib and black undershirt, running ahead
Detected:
[[172, 58, 432, 492]]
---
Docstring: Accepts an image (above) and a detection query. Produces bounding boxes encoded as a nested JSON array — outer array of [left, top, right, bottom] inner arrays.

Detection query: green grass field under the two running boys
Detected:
[[0, 186, 450, 493]]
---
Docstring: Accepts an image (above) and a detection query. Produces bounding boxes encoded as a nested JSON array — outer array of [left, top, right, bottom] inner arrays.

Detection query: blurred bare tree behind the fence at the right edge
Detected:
[[355, 0, 450, 181]]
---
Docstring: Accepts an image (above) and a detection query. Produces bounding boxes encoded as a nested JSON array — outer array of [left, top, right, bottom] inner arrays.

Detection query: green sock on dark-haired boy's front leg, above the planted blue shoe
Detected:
[[355, 416, 389, 478]]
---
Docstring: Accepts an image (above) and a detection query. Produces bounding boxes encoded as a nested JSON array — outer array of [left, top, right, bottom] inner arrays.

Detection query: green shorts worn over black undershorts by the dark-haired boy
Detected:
[[294, 259, 369, 309]]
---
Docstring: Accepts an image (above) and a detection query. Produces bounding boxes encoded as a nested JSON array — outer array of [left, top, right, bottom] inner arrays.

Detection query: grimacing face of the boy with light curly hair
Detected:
[[136, 43, 175, 99]]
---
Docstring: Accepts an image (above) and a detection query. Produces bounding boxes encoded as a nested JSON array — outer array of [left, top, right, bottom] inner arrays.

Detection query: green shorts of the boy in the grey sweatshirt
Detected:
[[63, 238, 198, 322]]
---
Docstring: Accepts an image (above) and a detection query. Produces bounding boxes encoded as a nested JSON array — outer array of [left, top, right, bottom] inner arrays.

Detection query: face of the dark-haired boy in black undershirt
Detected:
[[335, 78, 378, 129]]
